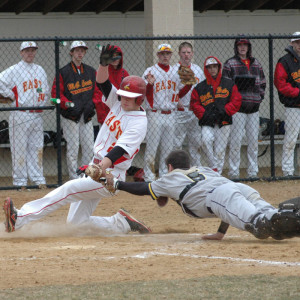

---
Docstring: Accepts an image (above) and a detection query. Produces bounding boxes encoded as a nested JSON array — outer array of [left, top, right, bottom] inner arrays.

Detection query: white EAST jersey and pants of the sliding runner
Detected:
[[15, 86, 147, 233]]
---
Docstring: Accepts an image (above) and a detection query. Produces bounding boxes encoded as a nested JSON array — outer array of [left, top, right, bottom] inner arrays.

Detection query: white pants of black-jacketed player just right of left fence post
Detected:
[[61, 115, 94, 179]]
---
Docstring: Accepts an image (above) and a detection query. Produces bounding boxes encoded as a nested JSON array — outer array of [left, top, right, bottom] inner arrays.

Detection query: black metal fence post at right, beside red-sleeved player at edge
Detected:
[[268, 35, 276, 179]]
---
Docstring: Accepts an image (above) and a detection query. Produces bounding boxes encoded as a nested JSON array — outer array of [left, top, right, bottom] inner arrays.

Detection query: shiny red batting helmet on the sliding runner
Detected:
[[117, 75, 146, 105]]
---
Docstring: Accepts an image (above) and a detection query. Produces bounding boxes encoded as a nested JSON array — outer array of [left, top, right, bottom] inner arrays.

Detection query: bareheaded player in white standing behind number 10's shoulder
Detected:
[[174, 42, 205, 166]]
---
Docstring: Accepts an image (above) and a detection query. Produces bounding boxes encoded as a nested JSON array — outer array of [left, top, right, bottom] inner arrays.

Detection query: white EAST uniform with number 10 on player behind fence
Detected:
[[142, 64, 179, 181]]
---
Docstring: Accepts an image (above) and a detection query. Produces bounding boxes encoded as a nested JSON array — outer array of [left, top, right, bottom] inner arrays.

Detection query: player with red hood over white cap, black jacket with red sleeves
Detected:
[[191, 56, 242, 174]]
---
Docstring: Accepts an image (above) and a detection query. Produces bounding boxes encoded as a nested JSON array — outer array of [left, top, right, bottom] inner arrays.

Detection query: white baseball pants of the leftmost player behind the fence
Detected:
[[9, 111, 46, 186]]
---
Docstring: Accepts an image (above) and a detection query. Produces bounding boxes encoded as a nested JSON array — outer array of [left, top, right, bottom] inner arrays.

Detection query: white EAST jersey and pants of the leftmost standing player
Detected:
[[0, 60, 49, 186]]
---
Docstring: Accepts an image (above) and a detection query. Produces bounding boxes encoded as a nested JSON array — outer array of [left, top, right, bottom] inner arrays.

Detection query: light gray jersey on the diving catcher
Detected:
[[150, 167, 230, 217]]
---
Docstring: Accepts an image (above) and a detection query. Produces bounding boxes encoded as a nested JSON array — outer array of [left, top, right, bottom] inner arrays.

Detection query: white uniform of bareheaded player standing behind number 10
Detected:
[[174, 63, 205, 166]]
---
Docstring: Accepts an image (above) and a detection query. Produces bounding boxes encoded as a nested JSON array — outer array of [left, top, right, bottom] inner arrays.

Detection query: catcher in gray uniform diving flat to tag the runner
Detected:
[[101, 150, 300, 240]]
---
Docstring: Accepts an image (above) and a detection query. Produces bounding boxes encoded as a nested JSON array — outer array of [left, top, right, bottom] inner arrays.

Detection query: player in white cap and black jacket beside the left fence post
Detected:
[[52, 41, 101, 179]]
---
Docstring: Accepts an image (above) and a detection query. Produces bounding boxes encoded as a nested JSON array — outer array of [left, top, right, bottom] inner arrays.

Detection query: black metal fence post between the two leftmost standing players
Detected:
[[55, 38, 62, 185]]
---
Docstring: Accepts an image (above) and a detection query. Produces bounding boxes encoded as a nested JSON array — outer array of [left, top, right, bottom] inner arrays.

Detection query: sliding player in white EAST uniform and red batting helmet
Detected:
[[3, 45, 150, 233]]
